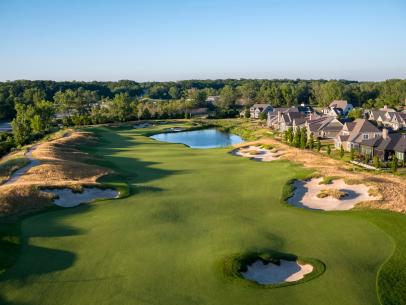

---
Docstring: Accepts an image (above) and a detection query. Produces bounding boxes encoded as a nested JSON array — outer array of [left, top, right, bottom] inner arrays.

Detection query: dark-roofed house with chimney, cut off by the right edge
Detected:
[[361, 128, 406, 161]]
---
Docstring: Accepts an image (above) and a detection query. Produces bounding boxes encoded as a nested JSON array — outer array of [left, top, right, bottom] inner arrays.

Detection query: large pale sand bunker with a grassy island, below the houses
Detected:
[[288, 178, 378, 211]]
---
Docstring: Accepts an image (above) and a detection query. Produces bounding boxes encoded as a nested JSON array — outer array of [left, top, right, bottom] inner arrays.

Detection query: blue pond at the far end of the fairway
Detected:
[[151, 128, 244, 149]]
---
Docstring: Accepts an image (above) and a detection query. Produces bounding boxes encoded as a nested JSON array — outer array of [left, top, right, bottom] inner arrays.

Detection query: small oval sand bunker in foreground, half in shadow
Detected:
[[241, 259, 313, 285]]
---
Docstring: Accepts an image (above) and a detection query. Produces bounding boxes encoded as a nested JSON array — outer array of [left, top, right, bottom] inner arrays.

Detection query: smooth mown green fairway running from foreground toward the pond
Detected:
[[0, 125, 406, 305]]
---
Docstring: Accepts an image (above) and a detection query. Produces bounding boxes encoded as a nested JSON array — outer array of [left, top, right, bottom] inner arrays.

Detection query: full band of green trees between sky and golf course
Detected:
[[0, 79, 406, 155]]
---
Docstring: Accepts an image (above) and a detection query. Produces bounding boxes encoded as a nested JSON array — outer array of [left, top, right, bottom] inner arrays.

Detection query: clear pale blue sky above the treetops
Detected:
[[0, 0, 406, 81]]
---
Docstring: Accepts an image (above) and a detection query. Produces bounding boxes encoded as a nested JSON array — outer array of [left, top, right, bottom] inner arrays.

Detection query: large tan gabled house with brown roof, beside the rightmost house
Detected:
[[334, 119, 382, 151]]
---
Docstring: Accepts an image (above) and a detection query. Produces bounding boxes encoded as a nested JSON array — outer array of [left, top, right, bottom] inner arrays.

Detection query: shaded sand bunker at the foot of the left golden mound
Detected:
[[43, 187, 118, 208]]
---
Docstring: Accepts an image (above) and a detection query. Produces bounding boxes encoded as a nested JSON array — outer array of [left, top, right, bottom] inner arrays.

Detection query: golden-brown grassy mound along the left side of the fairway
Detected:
[[0, 132, 110, 217]]
